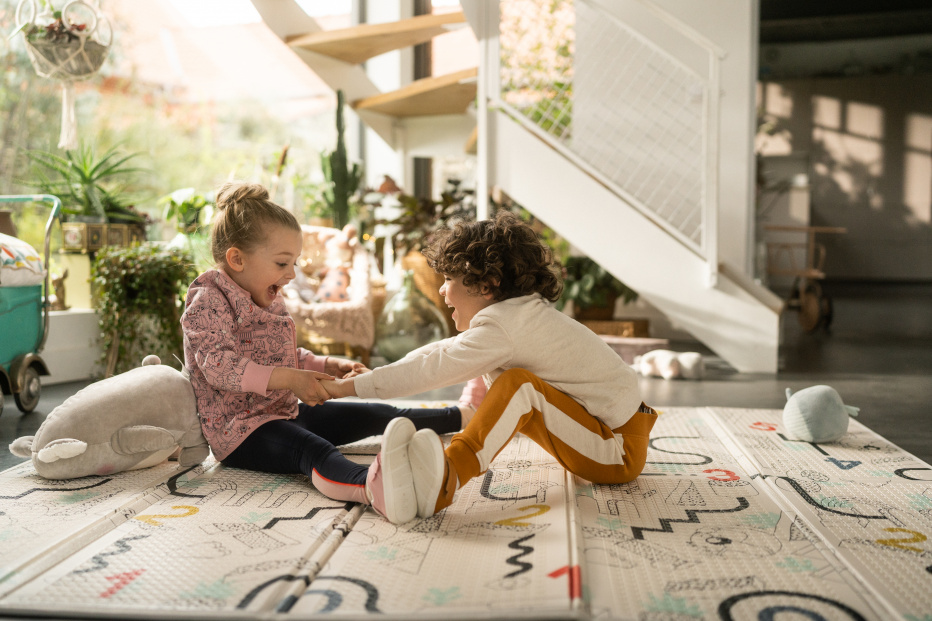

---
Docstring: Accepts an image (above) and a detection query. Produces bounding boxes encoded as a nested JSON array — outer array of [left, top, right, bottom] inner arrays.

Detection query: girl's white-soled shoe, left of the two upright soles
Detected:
[[366, 418, 417, 524]]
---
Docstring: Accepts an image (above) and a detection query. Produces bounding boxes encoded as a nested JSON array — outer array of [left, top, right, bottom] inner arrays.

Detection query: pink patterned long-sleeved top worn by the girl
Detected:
[[181, 270, 327, 460]]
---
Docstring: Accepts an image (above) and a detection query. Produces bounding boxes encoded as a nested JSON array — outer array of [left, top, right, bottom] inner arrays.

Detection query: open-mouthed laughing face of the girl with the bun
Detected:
[[224, 224, 302, 308]]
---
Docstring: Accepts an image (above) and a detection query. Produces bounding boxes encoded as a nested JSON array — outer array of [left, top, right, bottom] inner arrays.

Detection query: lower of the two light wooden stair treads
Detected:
[[352, 67, 479, 117]]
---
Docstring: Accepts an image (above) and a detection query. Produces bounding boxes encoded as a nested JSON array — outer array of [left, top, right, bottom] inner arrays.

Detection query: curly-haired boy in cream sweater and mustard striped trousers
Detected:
[[321, 211, 657, 517]]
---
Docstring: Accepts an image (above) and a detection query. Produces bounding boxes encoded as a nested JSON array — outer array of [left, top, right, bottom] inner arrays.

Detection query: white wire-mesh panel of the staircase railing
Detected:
[[489, 0, 721, 274]]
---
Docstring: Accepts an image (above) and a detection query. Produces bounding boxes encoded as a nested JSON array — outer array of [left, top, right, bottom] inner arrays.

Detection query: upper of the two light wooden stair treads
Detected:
[[285, 11, 466, 65]]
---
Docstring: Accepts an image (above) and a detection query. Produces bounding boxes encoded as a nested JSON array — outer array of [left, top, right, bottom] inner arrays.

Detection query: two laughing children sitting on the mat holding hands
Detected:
[[181, 184, 657, 523]]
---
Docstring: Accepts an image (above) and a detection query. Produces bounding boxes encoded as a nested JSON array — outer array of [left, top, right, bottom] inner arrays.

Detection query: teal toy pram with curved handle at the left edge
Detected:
[[0, 194, 61, 412]]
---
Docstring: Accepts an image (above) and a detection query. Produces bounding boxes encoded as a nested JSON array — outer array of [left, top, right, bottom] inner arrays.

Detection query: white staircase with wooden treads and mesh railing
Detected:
[[253, 0, 783, 373]]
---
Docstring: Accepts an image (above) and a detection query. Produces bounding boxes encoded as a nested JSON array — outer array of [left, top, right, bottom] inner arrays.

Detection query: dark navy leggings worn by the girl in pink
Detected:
[[223, 401, 460, 485]]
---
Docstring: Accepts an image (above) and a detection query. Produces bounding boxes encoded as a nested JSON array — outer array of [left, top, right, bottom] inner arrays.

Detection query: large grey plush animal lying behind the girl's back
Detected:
[[10, 356, 210, 479]]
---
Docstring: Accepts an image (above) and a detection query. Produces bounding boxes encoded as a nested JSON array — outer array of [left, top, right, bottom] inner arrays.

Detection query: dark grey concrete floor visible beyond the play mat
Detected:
[[0, 283, 932, 470]]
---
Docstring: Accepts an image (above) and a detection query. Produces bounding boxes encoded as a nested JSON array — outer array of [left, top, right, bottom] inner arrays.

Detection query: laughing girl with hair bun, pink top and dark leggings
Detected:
[[181, 184, 462, 523]]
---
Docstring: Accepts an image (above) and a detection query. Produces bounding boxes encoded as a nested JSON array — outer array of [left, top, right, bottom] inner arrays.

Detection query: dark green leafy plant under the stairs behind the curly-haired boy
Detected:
[[556, 256, 638, 321]]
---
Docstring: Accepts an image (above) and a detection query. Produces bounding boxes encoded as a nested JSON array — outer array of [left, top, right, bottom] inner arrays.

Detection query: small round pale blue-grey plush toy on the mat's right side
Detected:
[[783, 386, 859, 442]]
